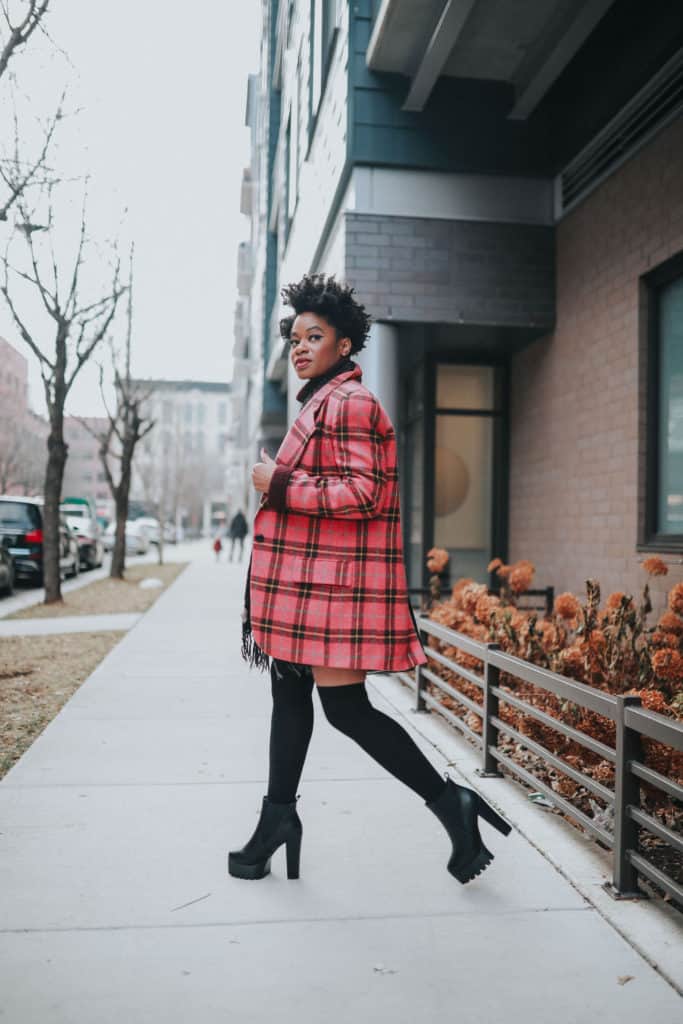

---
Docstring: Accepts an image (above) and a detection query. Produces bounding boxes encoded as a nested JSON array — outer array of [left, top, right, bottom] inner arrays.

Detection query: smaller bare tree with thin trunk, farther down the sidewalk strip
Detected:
[[91, 246, 155, 580]]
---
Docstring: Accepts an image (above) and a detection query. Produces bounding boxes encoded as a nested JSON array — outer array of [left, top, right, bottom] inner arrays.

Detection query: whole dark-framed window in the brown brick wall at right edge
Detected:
[[645, 253, 683, 548]]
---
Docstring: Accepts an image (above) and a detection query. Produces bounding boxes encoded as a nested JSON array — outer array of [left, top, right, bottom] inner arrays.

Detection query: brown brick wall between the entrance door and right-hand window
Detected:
[[510, 121, 683, 609]]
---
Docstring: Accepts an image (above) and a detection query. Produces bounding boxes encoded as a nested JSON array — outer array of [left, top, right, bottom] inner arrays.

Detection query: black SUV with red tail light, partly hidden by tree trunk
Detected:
[[0, 495, 80, 586]]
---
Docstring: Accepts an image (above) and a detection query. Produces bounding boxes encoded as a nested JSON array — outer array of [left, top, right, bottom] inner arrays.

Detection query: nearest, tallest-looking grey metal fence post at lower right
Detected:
[[604, 695, 647, 899]]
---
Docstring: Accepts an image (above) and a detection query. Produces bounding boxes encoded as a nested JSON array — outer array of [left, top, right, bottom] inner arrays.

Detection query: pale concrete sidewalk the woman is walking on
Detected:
[[0, 551, 681, 1024]]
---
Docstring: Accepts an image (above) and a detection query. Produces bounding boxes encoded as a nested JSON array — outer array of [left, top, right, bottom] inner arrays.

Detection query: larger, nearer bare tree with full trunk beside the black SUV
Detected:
[[0, 186, 125, 604]]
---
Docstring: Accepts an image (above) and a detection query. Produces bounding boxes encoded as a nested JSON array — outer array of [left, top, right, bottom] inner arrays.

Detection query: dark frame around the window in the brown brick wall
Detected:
[[636, 252, 683, 552]]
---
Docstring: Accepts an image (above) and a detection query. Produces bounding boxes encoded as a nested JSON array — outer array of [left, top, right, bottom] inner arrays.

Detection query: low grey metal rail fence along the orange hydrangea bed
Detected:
[[394, 615, 683, 904]]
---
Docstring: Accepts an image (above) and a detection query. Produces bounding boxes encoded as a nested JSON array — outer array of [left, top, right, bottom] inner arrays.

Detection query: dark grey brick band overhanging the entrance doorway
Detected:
[[345, 212, 554, 329]]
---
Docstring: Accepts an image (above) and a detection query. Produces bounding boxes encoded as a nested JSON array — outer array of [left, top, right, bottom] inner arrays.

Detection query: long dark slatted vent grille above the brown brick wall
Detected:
[[558, 49, 683, 214]]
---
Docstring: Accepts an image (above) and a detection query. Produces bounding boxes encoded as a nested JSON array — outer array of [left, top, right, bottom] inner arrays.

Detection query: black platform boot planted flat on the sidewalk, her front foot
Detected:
[[227, 797, 303, 879]]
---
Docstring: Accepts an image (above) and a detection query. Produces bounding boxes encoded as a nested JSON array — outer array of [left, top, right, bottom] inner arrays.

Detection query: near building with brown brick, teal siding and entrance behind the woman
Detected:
[[241, 0, 683, 602]]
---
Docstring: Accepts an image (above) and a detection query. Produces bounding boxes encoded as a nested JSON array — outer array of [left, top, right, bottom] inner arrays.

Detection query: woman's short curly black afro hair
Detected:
[[280, 273, 370, 354]]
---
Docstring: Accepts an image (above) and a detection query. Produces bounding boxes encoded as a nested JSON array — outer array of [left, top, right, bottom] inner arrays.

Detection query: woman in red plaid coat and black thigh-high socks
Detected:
[[228, 274, 510, 883]]
